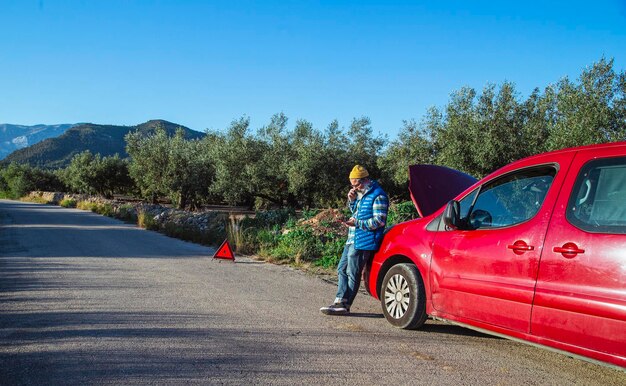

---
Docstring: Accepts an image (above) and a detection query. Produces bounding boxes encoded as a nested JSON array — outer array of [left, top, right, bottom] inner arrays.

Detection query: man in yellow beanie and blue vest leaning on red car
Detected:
[[320, 165, 389, 315]]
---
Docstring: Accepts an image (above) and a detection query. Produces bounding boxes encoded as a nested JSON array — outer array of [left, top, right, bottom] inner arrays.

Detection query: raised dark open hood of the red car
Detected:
[[409, 165, 478, 217]]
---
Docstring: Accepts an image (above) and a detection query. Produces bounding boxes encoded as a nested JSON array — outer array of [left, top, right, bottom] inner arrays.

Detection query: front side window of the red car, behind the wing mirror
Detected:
[[460, 165, 556, 229]]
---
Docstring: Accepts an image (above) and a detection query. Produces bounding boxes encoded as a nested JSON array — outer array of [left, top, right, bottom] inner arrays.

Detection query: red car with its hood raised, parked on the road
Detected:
[[365, 142, 626, 368]]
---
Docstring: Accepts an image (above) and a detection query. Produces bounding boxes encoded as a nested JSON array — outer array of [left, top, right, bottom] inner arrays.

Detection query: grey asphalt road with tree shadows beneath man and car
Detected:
[[0, 200, 626, 385]]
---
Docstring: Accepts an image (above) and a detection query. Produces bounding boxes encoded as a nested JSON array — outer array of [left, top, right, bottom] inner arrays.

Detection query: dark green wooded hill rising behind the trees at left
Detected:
[[2, 120, 204, 168]]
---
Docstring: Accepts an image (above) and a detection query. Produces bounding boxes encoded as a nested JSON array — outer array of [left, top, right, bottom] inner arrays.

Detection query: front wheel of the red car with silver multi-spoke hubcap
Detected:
[[380, 264, 426, 329]]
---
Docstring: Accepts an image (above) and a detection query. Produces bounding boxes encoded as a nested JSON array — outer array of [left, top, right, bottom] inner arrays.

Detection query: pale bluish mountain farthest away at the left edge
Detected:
[[0, 123, 74, 160]]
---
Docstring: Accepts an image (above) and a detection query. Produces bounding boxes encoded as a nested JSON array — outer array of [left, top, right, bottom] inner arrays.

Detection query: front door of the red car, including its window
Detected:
[[431, 153, 572, 332]]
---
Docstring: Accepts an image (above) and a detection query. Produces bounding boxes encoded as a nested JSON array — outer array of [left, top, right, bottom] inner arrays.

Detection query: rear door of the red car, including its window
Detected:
[[531, 146, 626, 357]]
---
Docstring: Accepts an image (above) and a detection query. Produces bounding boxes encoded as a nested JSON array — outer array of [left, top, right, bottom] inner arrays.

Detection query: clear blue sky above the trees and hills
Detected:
[[0, 0, 626, 139]]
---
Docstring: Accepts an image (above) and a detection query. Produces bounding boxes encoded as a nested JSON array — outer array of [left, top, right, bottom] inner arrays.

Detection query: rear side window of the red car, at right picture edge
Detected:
[[566, 157, 626, 234]]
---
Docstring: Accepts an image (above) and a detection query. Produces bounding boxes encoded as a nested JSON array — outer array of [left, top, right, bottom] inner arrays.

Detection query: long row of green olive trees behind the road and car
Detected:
[[0, 58, 626, 209]]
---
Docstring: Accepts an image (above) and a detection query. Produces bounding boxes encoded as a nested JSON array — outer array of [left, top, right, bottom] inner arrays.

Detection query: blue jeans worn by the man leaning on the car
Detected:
[[336, 244, 374, 307]]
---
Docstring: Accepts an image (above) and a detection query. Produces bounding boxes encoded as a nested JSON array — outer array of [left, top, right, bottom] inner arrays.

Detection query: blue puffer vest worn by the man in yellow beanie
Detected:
[[350, 181, 387, 251]]
